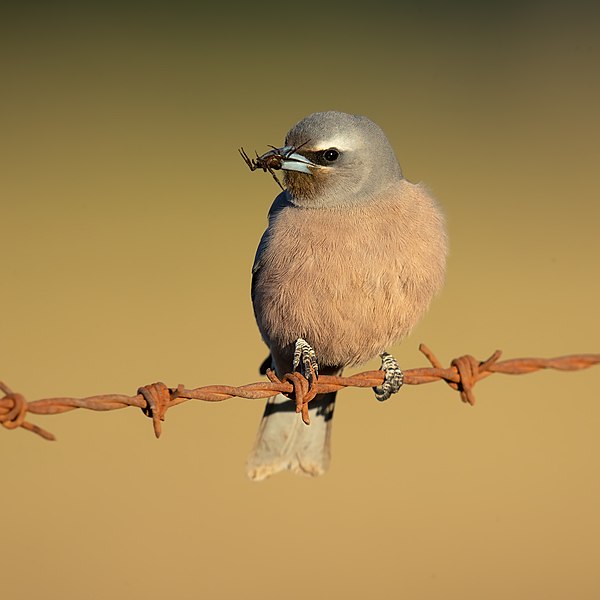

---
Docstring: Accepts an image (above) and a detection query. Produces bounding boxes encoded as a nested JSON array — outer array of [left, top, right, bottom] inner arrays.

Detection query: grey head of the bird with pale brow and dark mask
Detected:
[[281, 111, 402, 208]]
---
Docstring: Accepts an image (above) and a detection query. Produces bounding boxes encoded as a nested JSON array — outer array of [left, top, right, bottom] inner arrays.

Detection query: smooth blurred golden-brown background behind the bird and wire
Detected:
[[0, 2, 600, 600]]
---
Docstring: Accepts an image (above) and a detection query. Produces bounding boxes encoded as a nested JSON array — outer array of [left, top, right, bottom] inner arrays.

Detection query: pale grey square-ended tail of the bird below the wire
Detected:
[[246, 392, 336, 481]]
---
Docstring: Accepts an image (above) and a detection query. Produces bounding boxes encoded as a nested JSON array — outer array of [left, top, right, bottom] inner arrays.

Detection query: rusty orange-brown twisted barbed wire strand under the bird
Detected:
[[0, 344, 600, 440]]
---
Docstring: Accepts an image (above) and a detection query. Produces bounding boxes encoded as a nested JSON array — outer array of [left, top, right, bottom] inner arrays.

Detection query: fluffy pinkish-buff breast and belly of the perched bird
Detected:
[[253, 184, 443, 366]]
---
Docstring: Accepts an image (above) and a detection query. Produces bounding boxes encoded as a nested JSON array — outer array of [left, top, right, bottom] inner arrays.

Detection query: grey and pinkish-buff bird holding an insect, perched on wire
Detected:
[[240, 111, 448, 481]]
